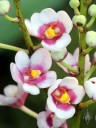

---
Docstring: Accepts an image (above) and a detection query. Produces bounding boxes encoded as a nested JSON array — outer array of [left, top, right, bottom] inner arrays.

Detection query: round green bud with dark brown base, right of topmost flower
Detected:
[[72, 15, 86, 26]]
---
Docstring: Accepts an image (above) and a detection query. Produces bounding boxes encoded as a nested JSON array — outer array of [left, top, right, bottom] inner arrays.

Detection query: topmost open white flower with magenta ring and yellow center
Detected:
[[25, 8, 73, 52]]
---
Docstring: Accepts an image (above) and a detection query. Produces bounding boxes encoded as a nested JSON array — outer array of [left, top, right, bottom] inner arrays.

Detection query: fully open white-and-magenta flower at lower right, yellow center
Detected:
[[47, 77, 85, 120]]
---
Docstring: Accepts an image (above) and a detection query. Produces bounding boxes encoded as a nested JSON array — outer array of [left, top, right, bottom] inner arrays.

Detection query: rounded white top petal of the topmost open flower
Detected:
[[40, 8, 58, 24]]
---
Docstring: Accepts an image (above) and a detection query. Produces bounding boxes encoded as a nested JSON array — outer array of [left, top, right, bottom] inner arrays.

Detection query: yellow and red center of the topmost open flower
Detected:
[[45, 24, 61, 39]]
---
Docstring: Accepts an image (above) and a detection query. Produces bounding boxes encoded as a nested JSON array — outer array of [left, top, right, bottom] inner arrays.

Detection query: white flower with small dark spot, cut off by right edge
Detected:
[[84, 77, 96, 100]]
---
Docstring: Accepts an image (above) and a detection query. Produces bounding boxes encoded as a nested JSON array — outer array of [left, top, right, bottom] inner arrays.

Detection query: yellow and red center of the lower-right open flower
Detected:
[[53, 87, 70, 103]]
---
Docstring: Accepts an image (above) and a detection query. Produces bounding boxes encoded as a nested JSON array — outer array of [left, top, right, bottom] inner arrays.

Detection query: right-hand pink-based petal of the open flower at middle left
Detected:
[[37, 71, 57, 88]]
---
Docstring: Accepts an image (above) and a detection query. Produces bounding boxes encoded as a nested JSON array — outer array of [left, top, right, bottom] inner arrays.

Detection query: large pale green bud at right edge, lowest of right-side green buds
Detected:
[[86, 31, 96, 48]]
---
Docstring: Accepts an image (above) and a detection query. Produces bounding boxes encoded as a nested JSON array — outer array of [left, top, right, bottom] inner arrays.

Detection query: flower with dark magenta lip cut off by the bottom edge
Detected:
[[37, 106, 67, 128]]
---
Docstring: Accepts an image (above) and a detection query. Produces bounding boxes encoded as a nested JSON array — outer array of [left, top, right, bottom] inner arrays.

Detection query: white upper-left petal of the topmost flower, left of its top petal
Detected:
[[31, 13, 43, 37]]
